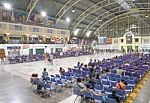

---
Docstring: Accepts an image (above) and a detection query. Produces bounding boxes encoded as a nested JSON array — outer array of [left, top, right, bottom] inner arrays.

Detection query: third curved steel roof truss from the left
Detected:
[[71, 0, 116, 34]]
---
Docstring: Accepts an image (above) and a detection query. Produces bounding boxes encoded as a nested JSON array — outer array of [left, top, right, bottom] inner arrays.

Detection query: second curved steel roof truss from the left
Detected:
[[55, 0, 81, 23]]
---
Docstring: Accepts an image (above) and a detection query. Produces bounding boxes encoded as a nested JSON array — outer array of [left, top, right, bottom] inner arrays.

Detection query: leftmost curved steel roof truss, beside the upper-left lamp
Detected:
[[26, 0, 39, 21]]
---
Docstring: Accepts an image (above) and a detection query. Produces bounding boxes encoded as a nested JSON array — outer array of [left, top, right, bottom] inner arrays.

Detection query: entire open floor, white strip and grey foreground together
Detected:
[[0, 53, 123, 103]]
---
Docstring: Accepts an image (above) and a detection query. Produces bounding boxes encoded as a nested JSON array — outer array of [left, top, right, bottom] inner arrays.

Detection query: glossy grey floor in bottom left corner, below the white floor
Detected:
[[0, 70, 71, 103]]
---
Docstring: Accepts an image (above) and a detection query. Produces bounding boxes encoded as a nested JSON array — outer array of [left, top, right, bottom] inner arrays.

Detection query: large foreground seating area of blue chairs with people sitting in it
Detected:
[[31, 53, 150, 103]]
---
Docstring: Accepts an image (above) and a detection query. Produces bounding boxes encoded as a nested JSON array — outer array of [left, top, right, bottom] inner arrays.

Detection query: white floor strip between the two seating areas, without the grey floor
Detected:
[[0, 53, 120, 80]]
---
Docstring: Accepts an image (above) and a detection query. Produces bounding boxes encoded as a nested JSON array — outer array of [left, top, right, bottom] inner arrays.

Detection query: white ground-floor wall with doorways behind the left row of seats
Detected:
[[0, 44, 78, 56]]
